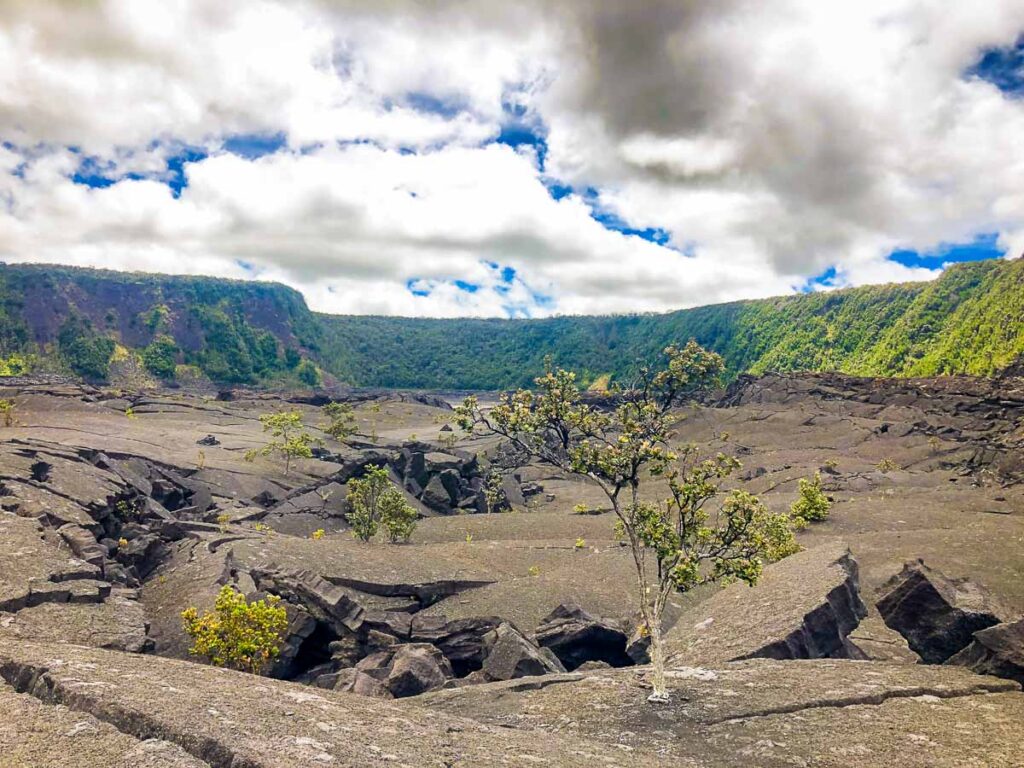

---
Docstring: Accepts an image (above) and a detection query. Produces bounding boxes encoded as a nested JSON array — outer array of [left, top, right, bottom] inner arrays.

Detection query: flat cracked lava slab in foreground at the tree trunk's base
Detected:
[[419, 658, 1024, 768]]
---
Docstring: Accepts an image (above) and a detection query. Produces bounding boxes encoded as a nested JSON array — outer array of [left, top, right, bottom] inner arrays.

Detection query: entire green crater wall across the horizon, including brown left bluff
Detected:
[[0, 260, 1024, 389]]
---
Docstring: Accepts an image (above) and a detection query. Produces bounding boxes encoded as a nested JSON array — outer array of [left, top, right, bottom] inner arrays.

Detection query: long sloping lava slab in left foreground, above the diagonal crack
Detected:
[[0, 643, 614, 768]]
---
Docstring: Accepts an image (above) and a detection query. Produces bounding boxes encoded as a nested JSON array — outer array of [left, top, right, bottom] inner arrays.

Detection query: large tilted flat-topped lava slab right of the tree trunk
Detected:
[[665, 545, 867, 664]]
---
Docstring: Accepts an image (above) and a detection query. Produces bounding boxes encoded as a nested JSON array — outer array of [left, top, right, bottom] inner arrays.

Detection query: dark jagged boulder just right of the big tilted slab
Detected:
[[878, 560, 1000, 664]]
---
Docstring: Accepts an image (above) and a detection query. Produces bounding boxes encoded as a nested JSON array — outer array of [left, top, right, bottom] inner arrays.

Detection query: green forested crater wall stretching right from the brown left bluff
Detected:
[[319, 260, 1024, 389]]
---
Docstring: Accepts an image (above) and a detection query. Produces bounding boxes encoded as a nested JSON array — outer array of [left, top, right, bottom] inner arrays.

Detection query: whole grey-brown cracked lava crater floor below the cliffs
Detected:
[[0, 375, 1024, 768]]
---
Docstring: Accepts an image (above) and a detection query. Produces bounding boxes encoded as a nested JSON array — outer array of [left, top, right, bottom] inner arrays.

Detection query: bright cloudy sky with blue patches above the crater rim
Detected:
[[0, 0, 1024, 316]]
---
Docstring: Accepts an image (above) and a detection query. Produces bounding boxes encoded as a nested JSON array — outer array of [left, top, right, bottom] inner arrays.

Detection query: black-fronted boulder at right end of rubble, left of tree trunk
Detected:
[[534, 603, 633, 670]]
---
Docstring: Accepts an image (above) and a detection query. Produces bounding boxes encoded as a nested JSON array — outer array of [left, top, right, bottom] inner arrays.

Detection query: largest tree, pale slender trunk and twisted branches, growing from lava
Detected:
[[457, 341, 797, 701]]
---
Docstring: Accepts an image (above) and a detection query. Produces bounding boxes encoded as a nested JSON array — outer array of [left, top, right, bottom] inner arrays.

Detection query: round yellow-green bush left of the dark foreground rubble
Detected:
[[181, 586, 288, 675]]
